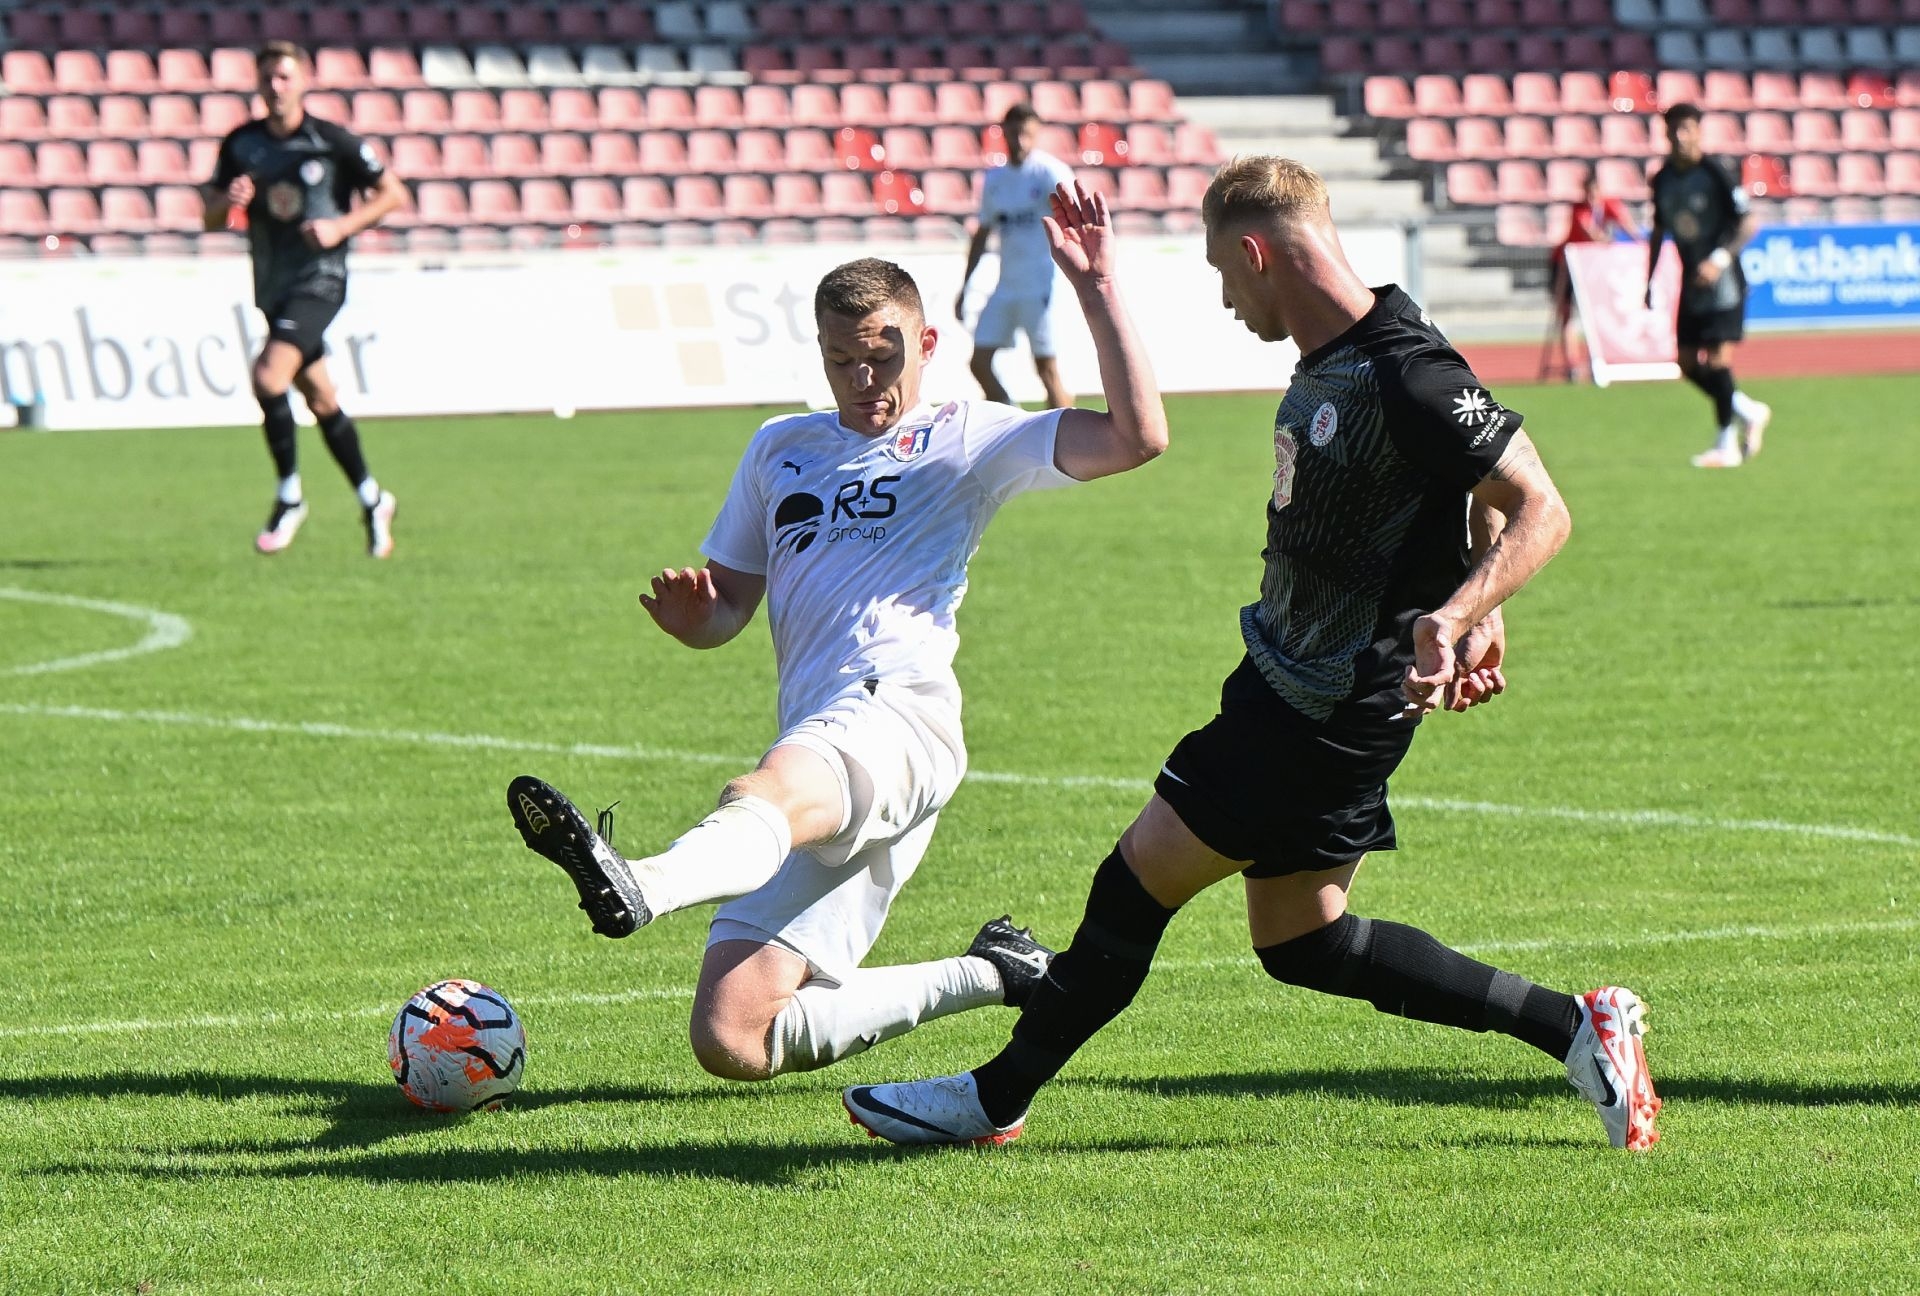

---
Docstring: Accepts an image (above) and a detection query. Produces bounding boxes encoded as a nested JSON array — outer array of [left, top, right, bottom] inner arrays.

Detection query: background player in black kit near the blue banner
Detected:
[[1647, 104, 1774, 468]]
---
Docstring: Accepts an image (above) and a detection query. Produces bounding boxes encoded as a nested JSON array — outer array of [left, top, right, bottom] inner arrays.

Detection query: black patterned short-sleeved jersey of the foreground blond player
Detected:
[[1240, 286, 1521, 720]]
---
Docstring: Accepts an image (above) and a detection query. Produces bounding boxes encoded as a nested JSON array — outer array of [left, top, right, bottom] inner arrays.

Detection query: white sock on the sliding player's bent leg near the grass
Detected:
[[768, 954, 1006, 1075]]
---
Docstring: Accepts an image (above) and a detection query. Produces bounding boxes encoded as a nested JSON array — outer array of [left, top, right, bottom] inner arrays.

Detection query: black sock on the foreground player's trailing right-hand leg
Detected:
[[1254, 914, 1578, 1062]]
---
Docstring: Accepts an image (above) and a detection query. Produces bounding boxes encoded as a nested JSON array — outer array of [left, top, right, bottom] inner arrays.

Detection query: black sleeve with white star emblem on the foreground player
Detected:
[[1375, 346, 1521, 490]]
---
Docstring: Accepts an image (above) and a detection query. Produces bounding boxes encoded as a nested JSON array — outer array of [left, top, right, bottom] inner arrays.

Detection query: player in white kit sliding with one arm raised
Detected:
[[507, 186, 1167, 1079]]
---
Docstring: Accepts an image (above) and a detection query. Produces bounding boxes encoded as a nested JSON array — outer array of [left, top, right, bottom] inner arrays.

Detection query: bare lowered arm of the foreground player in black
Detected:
[[1402, 432, 1572, 714]]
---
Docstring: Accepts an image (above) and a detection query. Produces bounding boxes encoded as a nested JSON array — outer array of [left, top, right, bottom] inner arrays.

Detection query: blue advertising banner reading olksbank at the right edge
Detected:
[[1740, 225, 1920, 328]]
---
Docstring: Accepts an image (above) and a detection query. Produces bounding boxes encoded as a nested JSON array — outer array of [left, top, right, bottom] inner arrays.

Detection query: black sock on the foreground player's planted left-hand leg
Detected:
[[973, 849, 1175, 1125]]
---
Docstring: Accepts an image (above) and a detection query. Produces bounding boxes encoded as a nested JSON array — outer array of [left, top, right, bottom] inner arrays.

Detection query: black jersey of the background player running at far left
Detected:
[[213, 113, 386, 309]]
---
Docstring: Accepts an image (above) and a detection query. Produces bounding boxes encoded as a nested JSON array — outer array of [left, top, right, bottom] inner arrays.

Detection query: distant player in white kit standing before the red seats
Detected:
[[954, 104, 1073, 409]]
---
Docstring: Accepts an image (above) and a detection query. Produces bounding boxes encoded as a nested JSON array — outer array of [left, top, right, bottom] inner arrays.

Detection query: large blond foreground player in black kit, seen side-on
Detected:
[[843, 157, 1659, 1148]]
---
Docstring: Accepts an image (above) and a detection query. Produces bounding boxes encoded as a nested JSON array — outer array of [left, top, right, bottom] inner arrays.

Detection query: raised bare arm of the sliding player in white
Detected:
[[1046, 182, 1167, 482]]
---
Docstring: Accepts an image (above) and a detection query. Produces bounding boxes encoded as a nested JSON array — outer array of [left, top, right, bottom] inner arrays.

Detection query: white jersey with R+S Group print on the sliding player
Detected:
[[701, 401, 1073, 730]]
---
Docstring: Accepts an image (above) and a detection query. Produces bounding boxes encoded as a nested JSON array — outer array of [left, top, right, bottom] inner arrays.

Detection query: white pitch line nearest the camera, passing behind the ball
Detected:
[[0, 918, 1920, 1039]]
